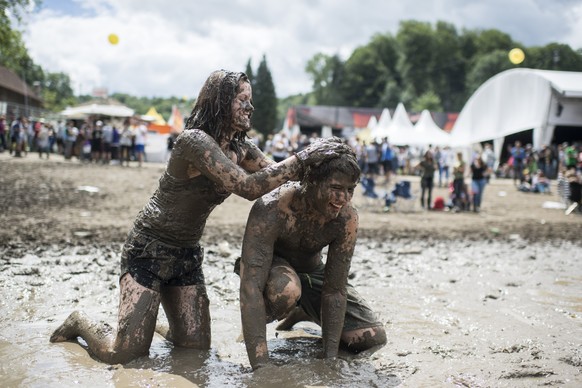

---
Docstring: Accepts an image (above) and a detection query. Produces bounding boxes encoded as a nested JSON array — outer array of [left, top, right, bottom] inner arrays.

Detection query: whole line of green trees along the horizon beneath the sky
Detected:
[[0, 0, 582, 139]]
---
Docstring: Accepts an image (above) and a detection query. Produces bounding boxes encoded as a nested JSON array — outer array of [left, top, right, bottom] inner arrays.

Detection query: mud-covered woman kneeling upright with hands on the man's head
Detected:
[[50, 70, 344, 364]]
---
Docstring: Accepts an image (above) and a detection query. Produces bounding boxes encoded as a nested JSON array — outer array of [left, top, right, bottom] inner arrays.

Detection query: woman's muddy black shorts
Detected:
[[121, 231, 204, 292]]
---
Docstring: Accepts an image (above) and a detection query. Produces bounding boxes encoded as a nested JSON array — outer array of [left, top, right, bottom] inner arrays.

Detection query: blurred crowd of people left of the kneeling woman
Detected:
[[0, 116, 148, 166]]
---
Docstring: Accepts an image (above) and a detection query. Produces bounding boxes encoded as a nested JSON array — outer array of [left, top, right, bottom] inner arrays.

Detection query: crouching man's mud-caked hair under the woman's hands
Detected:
[[302, 143, 362, 187]]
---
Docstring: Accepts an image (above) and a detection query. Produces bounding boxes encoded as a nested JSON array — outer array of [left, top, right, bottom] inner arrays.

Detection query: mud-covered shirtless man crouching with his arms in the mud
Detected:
[[235, 146, 386, 369]]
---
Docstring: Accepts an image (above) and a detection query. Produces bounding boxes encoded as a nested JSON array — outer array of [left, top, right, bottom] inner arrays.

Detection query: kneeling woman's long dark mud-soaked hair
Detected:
[[185, 70, 250, 158]]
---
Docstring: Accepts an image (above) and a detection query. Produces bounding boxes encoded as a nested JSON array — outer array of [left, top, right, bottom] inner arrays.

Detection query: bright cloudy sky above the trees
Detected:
[[24, 0, 582, 97]]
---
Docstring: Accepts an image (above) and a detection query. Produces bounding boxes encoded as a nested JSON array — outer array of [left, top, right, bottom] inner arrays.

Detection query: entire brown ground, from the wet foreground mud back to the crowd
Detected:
[[0, 153, 582, 387]]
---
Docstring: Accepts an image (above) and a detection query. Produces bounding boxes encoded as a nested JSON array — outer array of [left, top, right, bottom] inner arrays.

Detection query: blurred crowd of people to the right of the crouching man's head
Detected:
[[352, 138, 582, 213]]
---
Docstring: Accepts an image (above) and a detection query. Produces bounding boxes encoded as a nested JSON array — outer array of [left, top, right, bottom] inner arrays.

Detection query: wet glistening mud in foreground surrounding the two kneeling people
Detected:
[[0, 239, 582, 388]]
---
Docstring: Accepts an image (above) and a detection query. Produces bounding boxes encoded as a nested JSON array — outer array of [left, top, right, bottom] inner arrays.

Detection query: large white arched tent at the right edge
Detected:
[[451, 69, 582, 160]]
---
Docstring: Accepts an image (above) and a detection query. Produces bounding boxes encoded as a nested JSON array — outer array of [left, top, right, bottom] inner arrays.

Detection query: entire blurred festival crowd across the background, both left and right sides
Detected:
[[0, 110, 582, 212]]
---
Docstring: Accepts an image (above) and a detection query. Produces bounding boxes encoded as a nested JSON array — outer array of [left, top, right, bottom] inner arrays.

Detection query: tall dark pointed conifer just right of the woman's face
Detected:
[[253, 55, 277, 136]]
